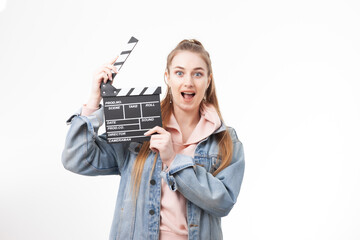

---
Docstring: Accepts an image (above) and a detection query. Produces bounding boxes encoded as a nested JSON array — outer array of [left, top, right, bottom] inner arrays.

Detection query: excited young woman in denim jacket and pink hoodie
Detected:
[[62, 39, 245, 240]]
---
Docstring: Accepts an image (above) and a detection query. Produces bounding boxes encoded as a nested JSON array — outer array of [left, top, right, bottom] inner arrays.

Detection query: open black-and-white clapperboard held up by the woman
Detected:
[[101, 37, 162, 143]]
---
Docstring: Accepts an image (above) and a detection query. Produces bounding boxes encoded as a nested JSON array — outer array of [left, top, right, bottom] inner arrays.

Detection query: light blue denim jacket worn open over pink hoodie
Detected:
[[62, 107, 245, 240]]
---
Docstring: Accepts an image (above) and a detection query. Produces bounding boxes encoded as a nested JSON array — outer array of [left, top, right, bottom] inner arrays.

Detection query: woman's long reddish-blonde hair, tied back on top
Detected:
[[131, 39, 233, 198]]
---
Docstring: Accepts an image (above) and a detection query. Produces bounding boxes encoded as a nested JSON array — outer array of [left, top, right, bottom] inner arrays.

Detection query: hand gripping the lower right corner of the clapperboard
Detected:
[[144, 126, 176, 166]]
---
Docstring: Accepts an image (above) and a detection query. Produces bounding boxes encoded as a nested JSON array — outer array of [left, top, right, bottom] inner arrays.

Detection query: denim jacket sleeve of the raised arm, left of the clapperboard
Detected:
[[61, 106, 127, 176]]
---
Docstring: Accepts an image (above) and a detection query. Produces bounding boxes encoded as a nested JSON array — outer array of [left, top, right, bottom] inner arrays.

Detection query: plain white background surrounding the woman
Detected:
[[0, 0, 360, 240]]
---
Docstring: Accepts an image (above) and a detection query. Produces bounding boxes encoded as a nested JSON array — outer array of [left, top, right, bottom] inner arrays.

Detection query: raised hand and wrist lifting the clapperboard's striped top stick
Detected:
[[87, 56, 119, 108]]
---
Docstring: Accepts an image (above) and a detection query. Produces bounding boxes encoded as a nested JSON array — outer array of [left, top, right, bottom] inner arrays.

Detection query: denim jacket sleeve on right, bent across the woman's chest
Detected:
[[161, 129, 245, 217]]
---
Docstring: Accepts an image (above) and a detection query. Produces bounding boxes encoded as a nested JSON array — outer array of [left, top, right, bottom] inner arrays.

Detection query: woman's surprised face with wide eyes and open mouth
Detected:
[[165, 51, 210, 111]]
